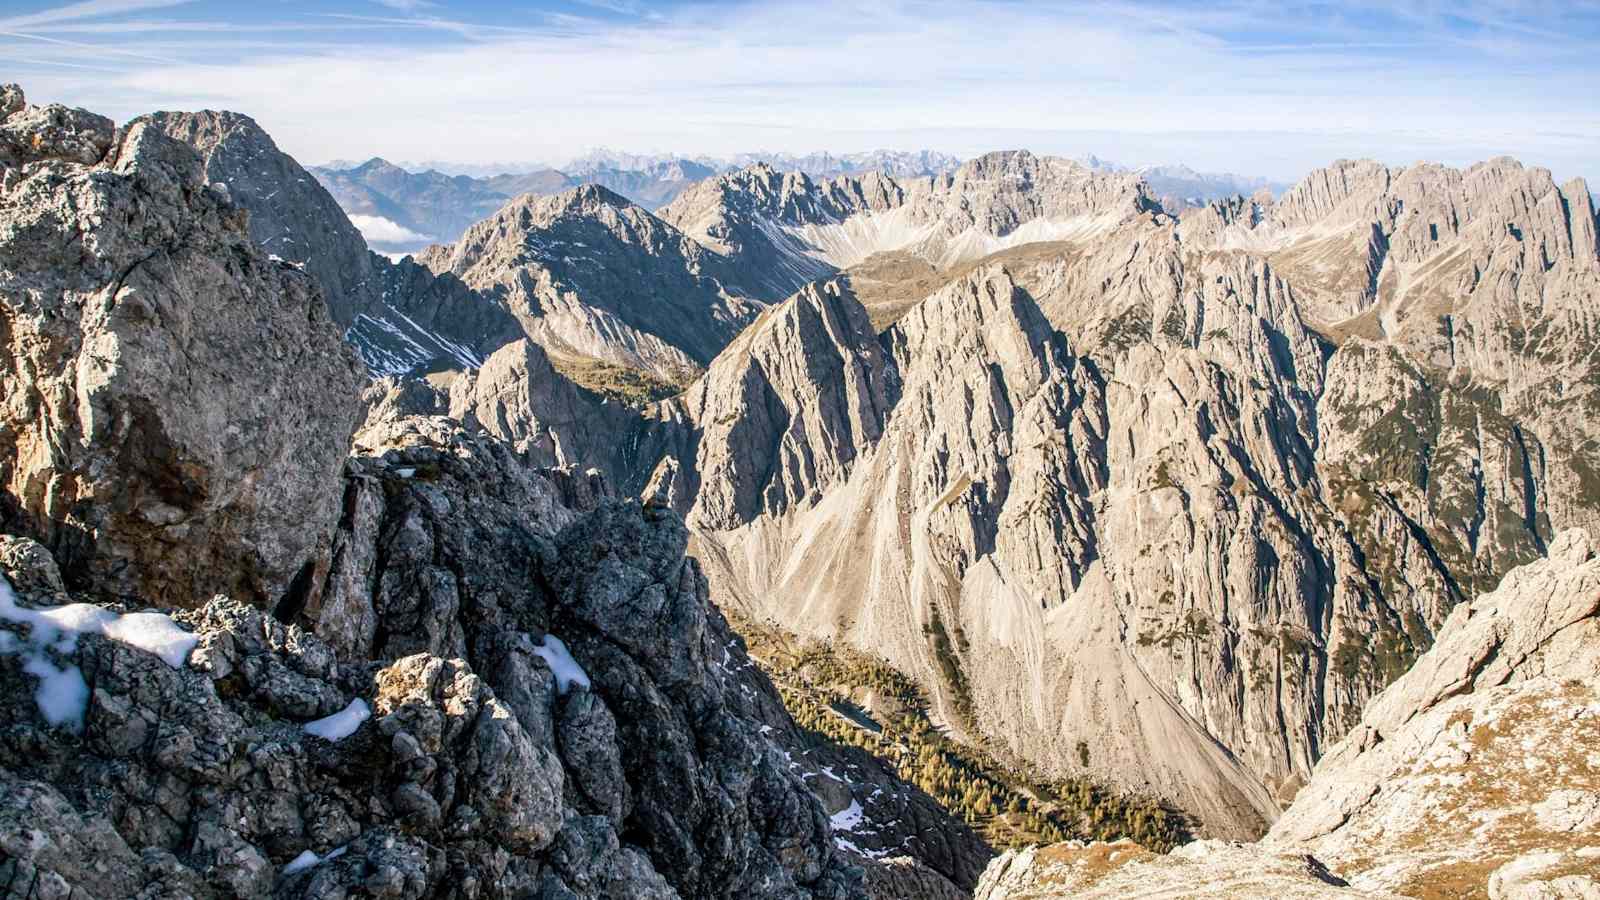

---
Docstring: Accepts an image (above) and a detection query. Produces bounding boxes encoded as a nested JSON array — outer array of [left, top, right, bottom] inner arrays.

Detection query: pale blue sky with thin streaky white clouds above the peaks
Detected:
[[0, 0, 1600, 184]]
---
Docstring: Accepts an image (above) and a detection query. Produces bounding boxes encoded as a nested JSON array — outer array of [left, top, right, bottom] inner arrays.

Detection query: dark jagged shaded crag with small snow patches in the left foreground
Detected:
[[0, 418, 864, 898]]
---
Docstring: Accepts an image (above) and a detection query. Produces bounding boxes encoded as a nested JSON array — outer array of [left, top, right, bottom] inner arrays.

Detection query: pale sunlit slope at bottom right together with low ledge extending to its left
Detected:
[[976, 530, 1600, 900]]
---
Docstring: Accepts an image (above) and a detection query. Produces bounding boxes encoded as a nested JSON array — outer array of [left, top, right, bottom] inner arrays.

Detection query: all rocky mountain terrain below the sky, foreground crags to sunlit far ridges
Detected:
[[0, 78, 1600, 900]]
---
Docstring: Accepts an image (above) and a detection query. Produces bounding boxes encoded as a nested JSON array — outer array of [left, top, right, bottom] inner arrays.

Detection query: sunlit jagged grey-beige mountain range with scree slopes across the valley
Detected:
[[168, 96, 1597, 838]]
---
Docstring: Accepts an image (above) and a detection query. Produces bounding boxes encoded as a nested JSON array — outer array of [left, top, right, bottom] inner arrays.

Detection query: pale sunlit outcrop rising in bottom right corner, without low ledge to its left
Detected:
[[1266, 530, 1600, 897]]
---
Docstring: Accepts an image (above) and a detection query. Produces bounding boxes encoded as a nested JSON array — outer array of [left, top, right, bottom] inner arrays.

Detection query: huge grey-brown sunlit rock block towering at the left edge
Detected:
[[0, 88, 363, 605]]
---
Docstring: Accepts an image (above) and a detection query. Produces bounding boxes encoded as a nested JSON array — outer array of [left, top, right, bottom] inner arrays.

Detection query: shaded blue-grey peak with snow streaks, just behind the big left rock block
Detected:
[[142, 110, 522, 375]]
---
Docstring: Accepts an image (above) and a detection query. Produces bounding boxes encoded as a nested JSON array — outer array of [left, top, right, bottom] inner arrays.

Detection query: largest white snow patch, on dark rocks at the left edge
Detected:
[[0, 578, 200, 730]]
